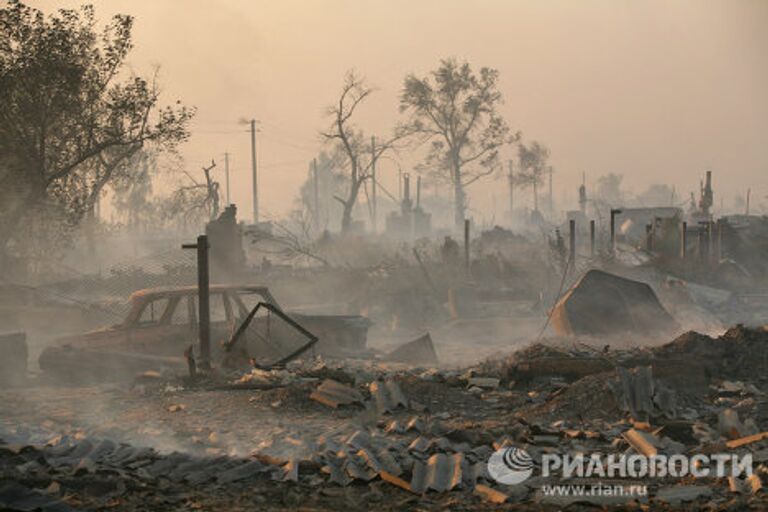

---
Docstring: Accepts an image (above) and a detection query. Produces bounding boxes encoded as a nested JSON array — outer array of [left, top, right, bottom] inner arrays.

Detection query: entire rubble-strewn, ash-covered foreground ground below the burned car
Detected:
[[0, 327, 768, 510]]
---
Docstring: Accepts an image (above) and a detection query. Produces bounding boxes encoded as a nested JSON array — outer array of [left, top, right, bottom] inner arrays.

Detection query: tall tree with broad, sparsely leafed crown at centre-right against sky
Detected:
[[400, 59, 519, 227]]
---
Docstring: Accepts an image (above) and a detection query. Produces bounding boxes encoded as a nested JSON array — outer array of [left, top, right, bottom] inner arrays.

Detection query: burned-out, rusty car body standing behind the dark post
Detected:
[[38, 285, 371, 378]]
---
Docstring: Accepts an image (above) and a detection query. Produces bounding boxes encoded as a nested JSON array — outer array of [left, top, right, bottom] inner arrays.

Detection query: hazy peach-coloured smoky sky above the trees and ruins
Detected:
[[32, 0, 768, 223]]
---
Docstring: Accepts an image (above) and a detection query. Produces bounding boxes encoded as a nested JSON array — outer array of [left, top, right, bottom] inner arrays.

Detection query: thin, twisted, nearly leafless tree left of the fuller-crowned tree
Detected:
[[320, 71, 404, 233]]
